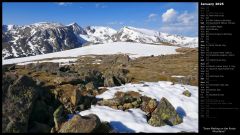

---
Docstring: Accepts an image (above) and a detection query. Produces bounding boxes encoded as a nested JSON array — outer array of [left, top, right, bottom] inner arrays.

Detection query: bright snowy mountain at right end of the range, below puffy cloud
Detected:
[[113, 27, 198, 47]]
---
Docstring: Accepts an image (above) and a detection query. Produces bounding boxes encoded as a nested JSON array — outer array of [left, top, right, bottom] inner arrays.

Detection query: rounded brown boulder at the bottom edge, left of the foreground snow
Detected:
[[58, 114, 101, 133]]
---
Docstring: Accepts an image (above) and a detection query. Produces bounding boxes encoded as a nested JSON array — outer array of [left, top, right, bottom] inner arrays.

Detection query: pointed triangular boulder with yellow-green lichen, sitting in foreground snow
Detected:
[[148, 97, 183, 127]]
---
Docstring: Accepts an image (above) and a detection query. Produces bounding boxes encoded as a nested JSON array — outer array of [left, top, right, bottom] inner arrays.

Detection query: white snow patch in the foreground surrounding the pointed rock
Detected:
[[79, 81, 198, 133]]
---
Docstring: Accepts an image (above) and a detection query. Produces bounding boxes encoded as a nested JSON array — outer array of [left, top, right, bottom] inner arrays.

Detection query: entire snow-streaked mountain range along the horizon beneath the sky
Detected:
[[2, 22, 198, 59]]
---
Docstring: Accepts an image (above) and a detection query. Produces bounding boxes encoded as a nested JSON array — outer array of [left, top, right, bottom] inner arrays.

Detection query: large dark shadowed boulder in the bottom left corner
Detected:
[[2, 76, 39, 133]]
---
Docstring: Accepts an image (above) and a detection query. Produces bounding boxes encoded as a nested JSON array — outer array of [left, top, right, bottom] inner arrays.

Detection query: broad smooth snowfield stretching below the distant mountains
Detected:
[[2, 42, 179, 65]]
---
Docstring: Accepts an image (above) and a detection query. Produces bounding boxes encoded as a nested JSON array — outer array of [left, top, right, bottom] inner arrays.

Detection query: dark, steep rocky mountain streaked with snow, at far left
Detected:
[[2, 22, 87, 58]]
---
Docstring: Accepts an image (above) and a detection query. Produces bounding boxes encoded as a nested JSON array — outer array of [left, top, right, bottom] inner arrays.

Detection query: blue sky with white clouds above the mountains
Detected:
[[2, 2, 198, 36]]
